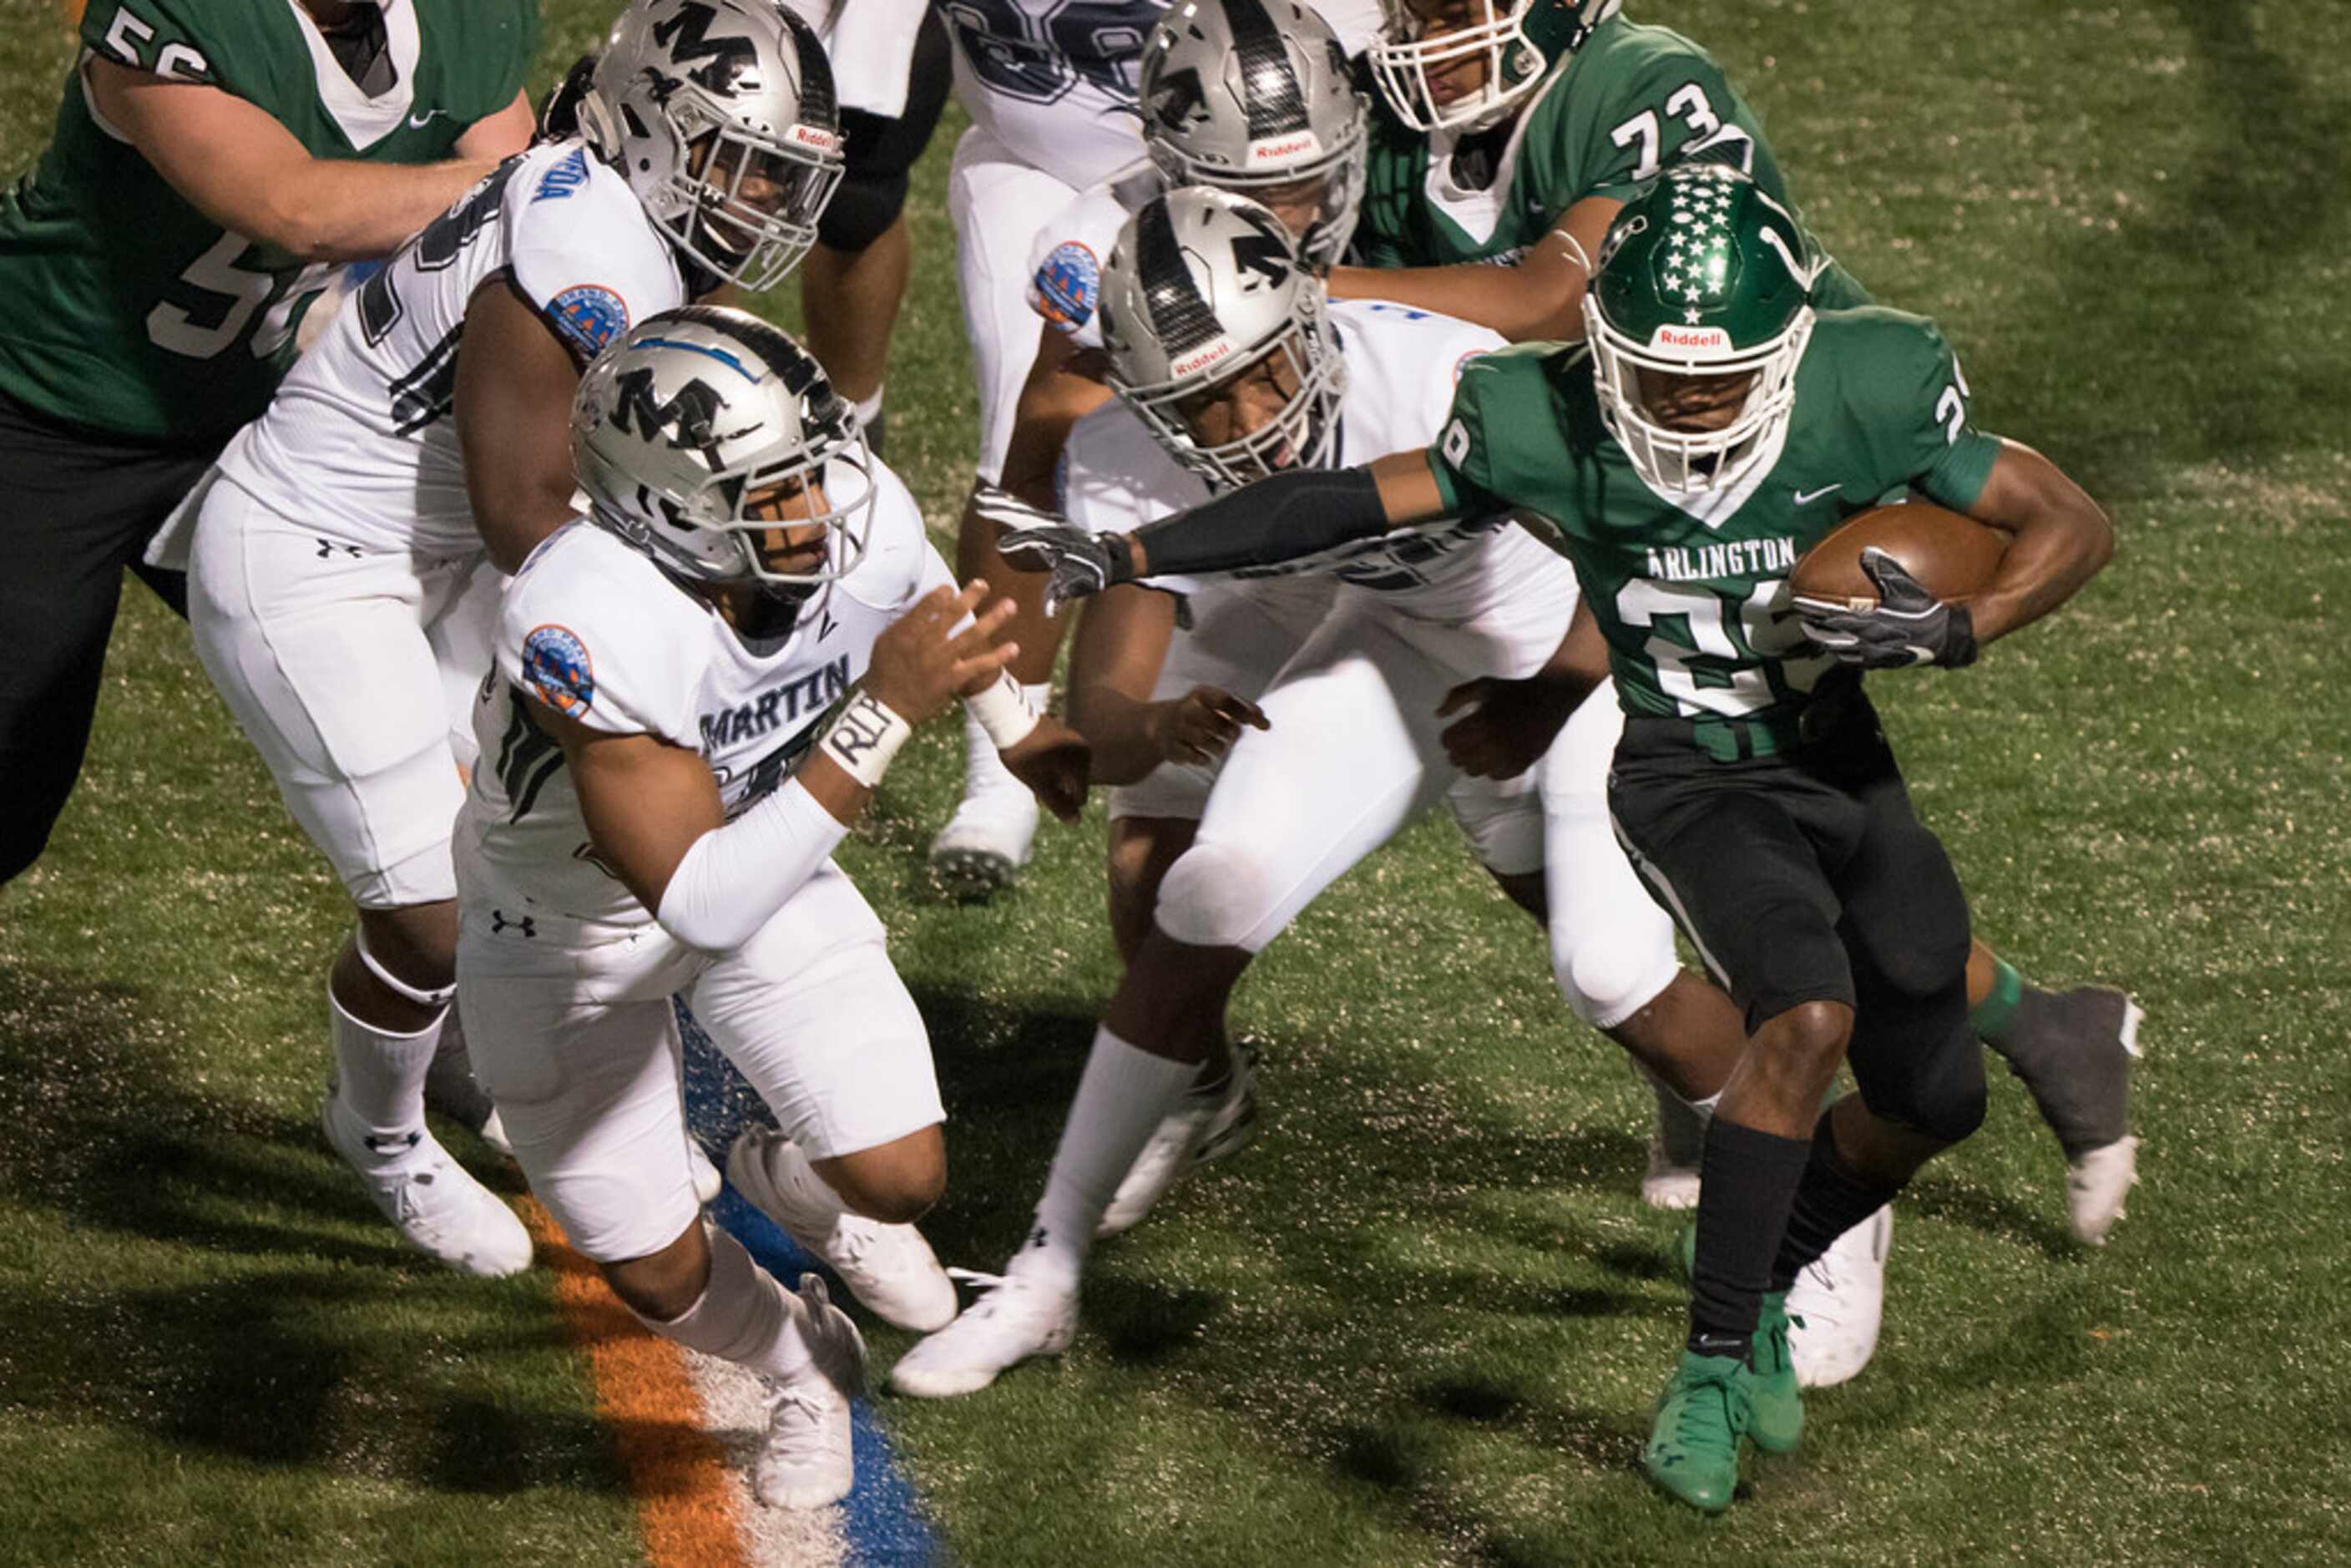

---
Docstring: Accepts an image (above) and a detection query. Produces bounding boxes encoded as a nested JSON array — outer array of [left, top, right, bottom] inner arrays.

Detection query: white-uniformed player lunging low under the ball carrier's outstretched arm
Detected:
[[891, 188, 1744, 1396]]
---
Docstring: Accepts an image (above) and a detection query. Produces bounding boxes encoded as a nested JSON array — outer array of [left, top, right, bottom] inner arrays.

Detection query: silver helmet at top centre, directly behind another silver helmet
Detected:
[[1135, 0, 1368, 273]]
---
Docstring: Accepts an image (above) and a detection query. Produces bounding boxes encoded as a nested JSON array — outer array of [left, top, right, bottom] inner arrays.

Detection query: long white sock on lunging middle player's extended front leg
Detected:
[[1006, 1029, 1199, 1291]]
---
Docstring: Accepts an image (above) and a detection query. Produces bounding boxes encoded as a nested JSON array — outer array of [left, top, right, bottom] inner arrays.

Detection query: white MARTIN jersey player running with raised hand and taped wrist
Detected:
[[456, 306, 1086, 1507]]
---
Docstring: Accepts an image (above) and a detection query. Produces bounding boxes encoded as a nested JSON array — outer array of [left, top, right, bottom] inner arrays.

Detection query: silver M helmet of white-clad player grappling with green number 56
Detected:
[[579, 0, 842, 291]]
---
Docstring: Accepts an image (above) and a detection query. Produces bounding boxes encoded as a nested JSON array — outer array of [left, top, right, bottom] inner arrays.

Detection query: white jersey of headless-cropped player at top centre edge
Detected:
[[931, 0, 1166, 190]]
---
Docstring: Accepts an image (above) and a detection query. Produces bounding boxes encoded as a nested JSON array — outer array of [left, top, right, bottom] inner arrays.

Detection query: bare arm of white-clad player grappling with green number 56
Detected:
[[453, 275, 579, 571]]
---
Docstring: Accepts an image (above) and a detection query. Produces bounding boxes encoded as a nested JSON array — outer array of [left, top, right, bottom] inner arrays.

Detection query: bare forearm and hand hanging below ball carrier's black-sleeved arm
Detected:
[[1069, 583, 1267, 785]]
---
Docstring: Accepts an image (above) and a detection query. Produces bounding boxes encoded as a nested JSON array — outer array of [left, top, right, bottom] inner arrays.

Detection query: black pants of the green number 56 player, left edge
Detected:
[[0, 395, 221, 882]]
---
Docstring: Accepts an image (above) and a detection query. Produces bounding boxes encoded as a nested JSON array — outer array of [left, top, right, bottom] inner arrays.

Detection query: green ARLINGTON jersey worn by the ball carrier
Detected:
[[1432, 306, 2000, 724]]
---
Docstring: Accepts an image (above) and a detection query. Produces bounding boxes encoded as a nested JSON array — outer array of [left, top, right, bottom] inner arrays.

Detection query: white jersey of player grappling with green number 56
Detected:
[[219, 141, 686, 554]]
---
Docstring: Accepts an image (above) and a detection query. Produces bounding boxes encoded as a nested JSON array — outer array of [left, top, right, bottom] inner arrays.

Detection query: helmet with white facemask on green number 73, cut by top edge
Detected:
[[1371, 0, 1622, 132]]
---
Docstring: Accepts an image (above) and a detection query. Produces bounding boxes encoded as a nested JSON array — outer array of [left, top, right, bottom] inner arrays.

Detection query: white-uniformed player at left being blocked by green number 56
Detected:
[[181, 0, 842, 1274]]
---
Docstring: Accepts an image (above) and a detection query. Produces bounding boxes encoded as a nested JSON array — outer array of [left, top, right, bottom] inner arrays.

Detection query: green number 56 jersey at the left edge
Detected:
[[0, 0, 538, 442]]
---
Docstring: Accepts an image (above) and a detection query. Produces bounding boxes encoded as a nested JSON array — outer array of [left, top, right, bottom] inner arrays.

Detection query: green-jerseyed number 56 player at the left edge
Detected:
[[0, 0, 538, 882]]
